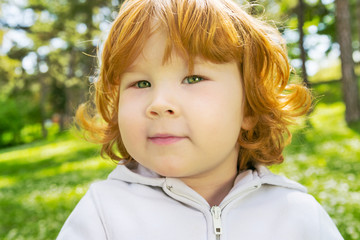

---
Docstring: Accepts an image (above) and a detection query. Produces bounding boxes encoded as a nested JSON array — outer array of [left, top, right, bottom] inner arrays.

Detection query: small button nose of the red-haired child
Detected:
[[146, 91, 180, 119]]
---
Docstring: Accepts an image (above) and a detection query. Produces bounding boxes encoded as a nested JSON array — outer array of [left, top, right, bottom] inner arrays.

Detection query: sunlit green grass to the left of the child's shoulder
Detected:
[[0, 135, 114, 240]]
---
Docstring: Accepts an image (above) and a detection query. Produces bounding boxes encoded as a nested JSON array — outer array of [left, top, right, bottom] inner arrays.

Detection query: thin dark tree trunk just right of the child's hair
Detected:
[[298, 0, 310, 88]]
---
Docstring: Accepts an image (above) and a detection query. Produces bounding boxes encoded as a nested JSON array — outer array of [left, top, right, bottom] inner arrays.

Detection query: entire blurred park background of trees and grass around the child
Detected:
[[0, 0, 360, 240]]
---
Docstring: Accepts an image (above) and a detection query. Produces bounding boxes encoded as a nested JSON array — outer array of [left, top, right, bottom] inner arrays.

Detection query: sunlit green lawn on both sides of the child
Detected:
[[0, 102, 360, 240]]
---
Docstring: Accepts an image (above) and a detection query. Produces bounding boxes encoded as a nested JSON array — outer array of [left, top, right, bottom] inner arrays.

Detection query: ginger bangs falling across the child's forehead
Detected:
[[103, 0, 248, 83]]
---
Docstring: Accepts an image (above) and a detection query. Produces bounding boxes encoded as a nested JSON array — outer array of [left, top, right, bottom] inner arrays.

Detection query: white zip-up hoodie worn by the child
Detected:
[[57, 165, 343, 240]]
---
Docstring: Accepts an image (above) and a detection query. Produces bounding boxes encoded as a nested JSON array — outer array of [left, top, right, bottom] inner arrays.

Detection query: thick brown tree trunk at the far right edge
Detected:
[[335, 0, 360, 123]]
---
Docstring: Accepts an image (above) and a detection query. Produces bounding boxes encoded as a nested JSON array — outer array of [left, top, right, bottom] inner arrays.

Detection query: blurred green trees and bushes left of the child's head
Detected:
[[0, 0, 121, 142]]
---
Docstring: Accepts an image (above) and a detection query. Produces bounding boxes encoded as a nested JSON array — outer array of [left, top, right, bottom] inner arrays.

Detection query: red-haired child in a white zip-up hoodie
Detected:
[[58, 0, 342, 240]]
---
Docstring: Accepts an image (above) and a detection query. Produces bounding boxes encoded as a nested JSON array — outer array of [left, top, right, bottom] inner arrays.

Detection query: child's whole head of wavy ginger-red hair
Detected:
[[76, 0, 311, 170]]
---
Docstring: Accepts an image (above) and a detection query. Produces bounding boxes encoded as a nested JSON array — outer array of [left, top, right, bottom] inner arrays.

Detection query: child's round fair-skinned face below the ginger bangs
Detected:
[[119, 31, 248, 183]]
